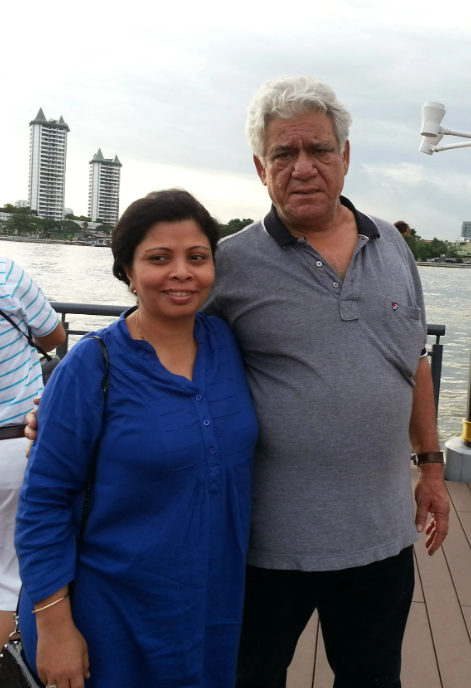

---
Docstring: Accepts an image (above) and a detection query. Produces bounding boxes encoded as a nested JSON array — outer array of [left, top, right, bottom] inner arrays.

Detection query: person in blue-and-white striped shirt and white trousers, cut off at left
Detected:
[[0, 256, 65, 647]]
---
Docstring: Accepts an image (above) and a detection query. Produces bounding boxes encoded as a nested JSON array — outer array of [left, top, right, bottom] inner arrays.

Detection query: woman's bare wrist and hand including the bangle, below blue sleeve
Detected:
[[34, 586, 90, 688]]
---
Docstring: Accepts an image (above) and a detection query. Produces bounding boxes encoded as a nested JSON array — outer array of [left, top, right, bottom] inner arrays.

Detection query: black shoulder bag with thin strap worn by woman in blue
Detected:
[[0, 336, 109, 688]]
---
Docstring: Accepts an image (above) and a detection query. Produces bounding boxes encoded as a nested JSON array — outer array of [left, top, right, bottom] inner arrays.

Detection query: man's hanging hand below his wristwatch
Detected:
[[415, 464, 450, 555]]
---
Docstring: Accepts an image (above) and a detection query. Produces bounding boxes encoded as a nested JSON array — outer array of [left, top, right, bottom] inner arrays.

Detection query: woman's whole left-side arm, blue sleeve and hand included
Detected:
[[16, 340, 104, 688]]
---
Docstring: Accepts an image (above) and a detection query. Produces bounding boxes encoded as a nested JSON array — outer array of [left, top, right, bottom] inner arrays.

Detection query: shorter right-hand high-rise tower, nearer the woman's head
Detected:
[[88, 148, 122, 225]]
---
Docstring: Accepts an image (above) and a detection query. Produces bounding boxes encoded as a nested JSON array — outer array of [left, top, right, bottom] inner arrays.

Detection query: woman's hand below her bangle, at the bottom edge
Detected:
[[36, 621, 90, 688]]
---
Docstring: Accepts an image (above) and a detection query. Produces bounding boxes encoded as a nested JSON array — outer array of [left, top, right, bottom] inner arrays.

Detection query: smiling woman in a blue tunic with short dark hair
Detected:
[[16, 189, 257, 688]]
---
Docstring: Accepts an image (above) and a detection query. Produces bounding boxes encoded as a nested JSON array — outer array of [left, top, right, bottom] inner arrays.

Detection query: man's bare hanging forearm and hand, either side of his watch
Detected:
[[409, 357, 450, 554]]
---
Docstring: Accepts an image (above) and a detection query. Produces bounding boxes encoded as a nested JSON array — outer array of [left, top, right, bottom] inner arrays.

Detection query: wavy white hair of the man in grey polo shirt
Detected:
[[245, 76, 352, 159]]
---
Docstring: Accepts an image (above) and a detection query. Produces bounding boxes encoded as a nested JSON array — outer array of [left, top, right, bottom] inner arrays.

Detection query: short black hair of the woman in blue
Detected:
[[111, 189, 220, 286]]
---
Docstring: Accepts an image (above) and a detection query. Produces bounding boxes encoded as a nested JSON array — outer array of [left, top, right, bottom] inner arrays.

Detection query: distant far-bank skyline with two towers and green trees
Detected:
[[0, 108, 471, 254]]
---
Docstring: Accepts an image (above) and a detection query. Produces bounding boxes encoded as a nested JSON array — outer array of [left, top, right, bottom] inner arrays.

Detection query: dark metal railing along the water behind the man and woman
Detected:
[[52, 301, 446, 413]]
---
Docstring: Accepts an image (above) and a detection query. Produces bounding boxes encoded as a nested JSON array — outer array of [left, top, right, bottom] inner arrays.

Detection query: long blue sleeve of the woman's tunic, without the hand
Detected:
[[15, 339, 104, 603]]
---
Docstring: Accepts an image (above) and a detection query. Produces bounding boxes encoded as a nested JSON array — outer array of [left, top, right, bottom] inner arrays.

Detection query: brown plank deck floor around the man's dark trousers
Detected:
[[288, 469, 471, 688]]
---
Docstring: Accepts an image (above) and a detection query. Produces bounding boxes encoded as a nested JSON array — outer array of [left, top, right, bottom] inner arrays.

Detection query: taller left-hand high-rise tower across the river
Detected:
[[28, 108, 70, 220]]
